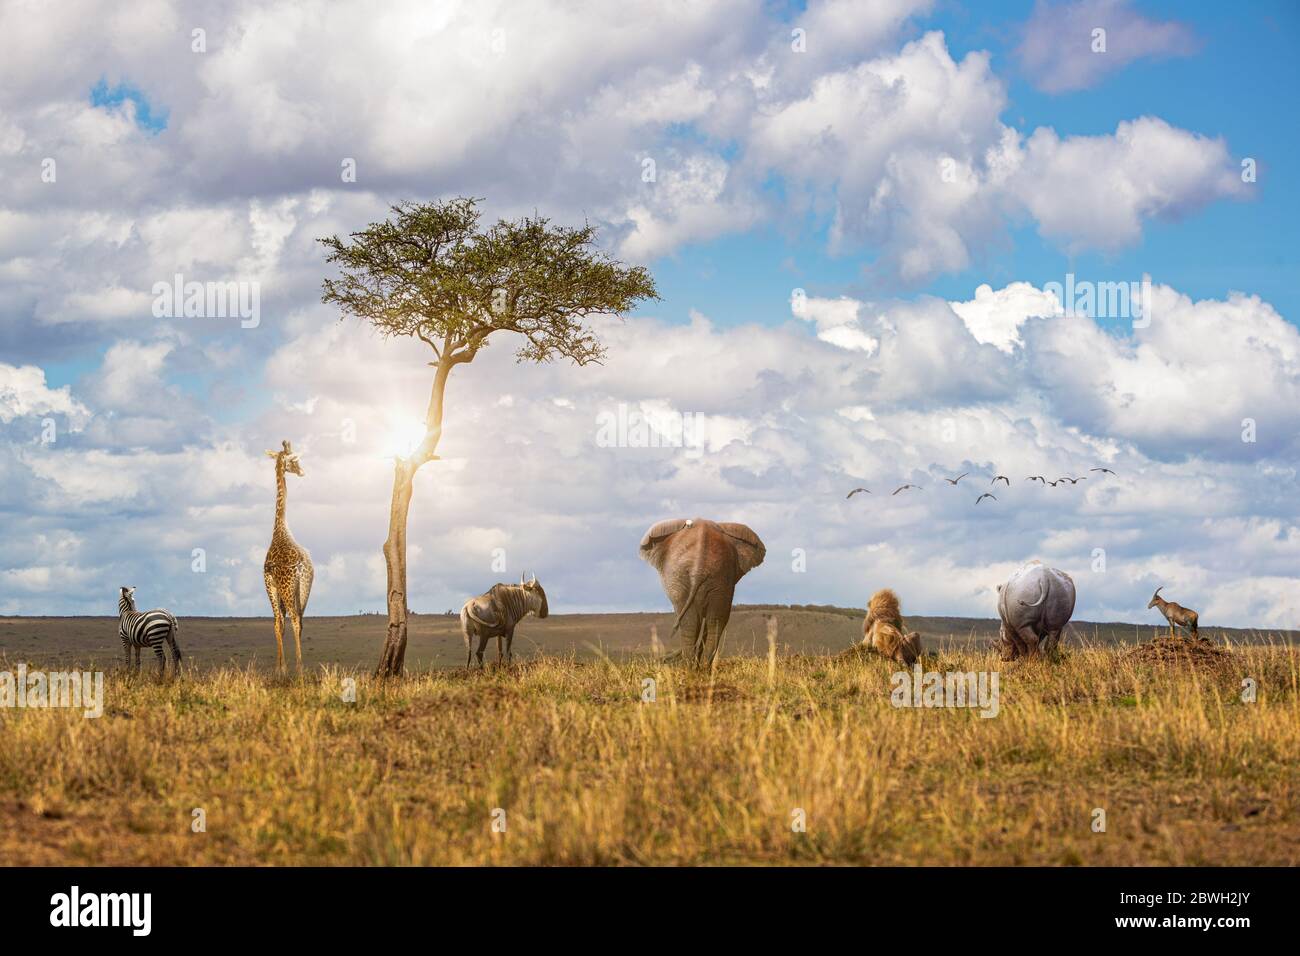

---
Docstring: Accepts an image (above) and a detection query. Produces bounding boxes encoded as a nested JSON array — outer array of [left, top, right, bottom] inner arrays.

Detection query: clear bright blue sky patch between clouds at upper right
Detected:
[[655, 0, 1300, 324]]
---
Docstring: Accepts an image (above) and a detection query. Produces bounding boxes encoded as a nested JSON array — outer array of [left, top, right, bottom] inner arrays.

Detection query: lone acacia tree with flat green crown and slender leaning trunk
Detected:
[[319, 198, 659, 676]]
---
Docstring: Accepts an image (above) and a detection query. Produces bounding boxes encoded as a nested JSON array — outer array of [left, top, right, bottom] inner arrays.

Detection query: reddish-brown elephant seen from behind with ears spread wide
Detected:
[[640, 518, 767, 667]]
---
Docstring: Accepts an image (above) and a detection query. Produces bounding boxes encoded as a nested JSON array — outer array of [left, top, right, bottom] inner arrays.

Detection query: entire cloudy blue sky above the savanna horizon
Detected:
[[0, 0, 1300, 627]]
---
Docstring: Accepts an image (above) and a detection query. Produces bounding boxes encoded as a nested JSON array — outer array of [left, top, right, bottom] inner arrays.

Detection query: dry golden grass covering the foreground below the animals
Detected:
[[0, 646, 1300, 865]]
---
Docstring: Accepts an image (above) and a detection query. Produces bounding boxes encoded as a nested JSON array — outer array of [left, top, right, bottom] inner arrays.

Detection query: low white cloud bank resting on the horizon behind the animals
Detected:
[[0, 282, 1300, 627]]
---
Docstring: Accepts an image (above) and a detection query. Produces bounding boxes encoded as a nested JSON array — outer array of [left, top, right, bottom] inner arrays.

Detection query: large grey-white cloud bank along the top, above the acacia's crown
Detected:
[[0, 0, 1243, 299]]
